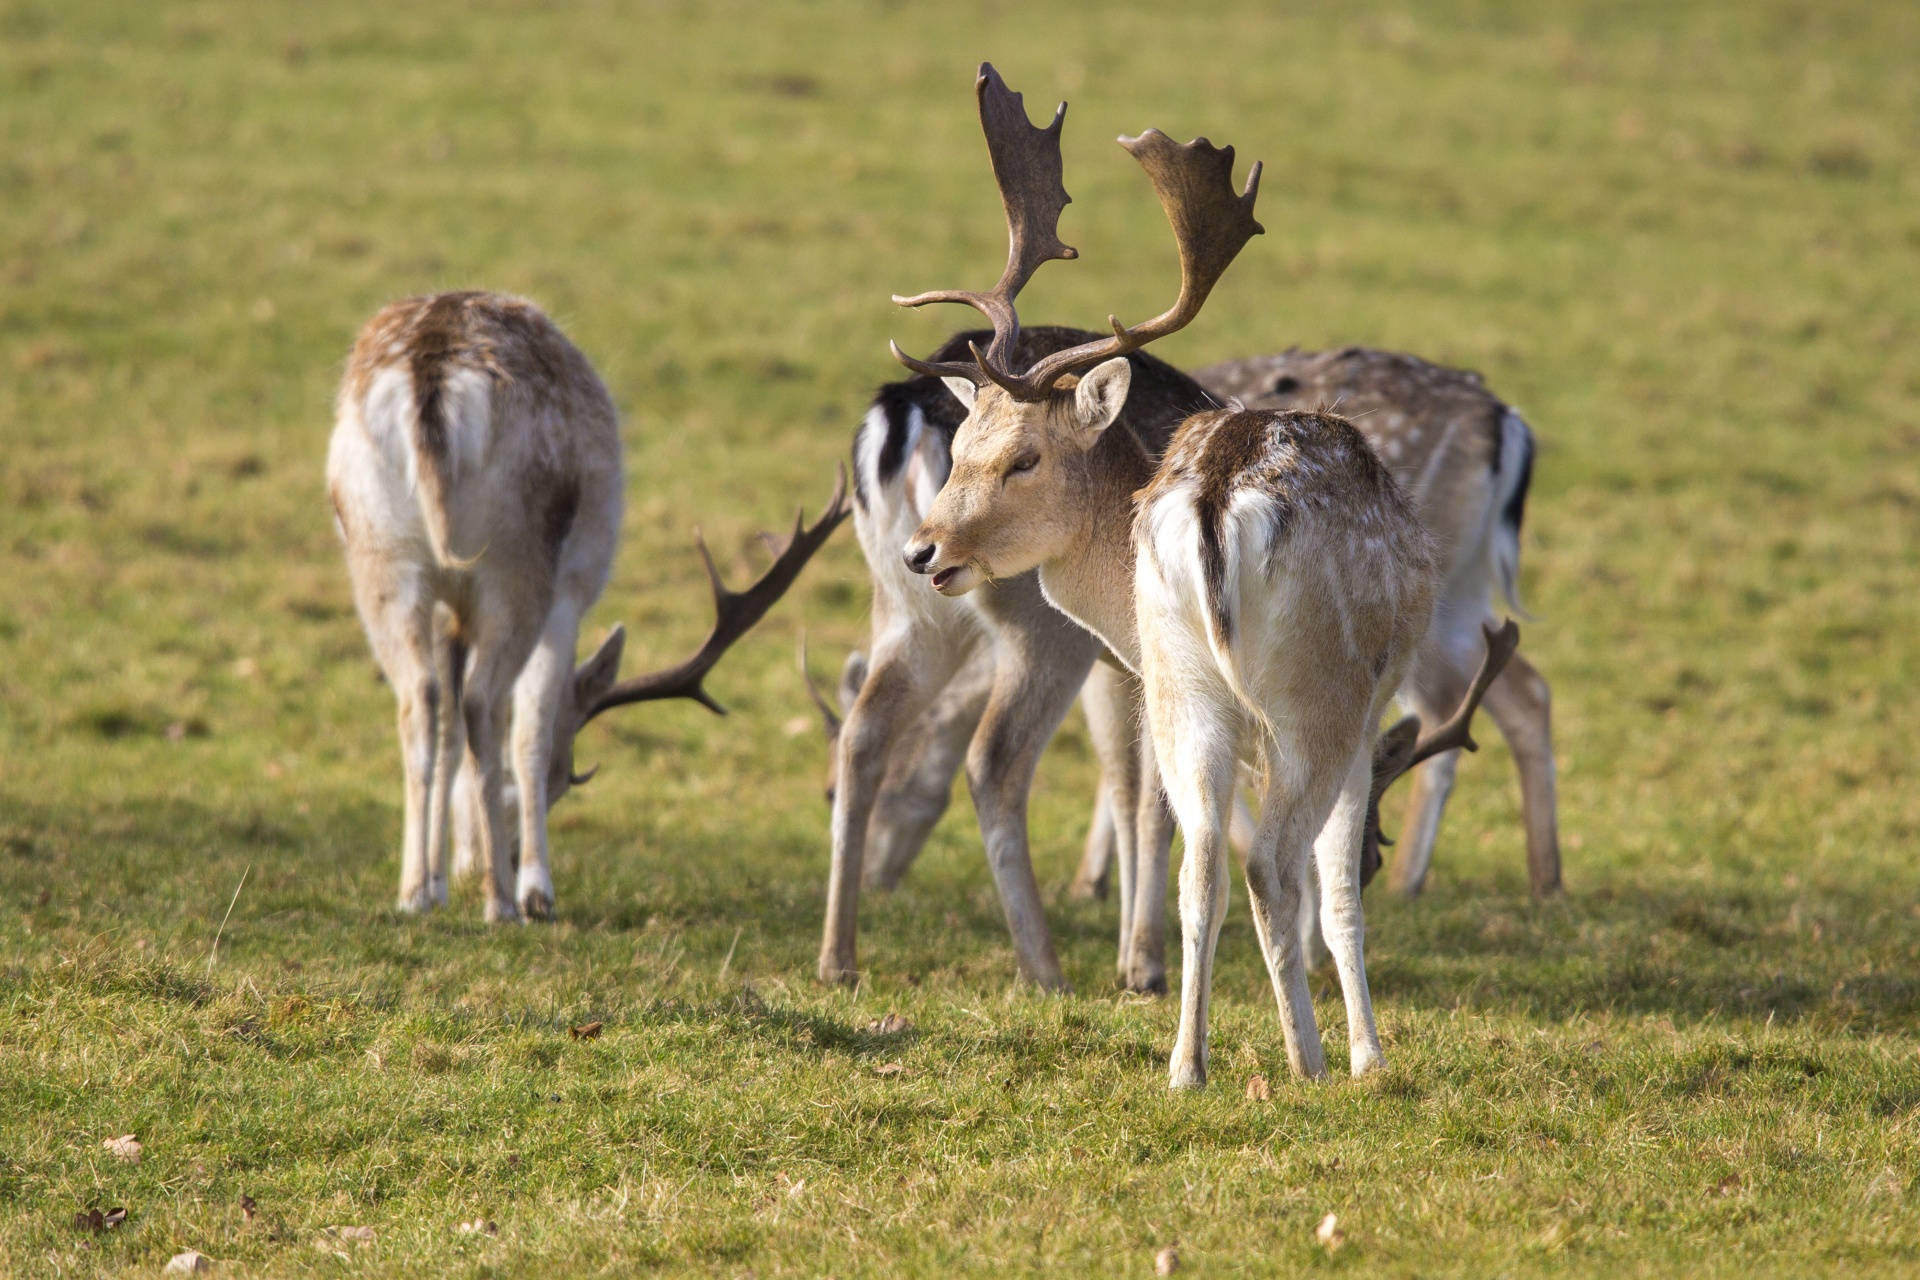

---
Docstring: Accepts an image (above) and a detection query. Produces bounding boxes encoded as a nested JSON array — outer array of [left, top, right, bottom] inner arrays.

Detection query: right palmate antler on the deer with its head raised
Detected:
[[1014, 129, 1267, 399]]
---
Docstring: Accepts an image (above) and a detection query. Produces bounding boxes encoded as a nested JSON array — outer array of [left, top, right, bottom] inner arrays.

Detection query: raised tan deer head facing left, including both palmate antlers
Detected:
[[893, 63, 1263, 595]]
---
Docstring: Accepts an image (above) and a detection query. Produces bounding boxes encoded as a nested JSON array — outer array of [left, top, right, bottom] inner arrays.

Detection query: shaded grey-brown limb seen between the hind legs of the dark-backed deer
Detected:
[[860, 645, 993, 889]]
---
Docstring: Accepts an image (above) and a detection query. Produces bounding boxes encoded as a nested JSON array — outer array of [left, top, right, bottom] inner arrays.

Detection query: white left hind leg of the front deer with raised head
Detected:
[[1142, 671, 1236, 1088]]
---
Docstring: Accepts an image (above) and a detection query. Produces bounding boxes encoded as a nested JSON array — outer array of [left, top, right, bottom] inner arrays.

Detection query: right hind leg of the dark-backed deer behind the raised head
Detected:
[[966, 610, 1100, 990]]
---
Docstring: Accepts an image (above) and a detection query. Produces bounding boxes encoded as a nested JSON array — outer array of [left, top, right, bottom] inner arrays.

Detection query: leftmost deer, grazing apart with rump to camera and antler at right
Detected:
[[326, 292, 849, 921]]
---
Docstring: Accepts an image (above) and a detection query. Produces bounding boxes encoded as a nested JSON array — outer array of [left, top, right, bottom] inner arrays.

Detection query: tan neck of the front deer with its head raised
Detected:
[[1041, 424, 1154, 672]]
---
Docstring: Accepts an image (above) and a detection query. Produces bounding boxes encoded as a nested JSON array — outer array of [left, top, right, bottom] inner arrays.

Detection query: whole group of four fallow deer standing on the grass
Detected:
[[326, 65, 1561, 1088]]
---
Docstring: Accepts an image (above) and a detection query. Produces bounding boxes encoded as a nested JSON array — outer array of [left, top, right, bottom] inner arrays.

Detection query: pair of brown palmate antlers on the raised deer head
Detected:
[[893, 63, 1265, 401]]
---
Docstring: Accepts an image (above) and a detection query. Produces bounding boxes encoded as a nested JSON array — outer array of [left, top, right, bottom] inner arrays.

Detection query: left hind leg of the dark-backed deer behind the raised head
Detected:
[[818, 628, 979, 983]]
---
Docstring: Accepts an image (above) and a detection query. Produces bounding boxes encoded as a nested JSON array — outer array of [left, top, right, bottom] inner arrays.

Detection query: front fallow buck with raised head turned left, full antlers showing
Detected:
[[893, 67, 1434, 1088]]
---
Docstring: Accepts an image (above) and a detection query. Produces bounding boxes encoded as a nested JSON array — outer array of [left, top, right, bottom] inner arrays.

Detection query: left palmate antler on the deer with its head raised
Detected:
[[893, 61, 1079, 384]]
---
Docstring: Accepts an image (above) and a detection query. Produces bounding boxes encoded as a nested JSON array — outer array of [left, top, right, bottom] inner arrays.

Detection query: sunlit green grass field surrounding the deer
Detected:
[[0, 0, 1920, 1278]]
